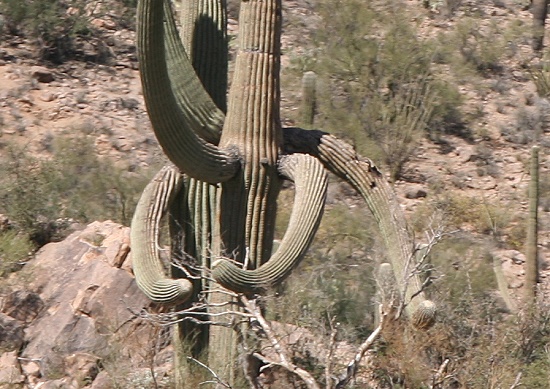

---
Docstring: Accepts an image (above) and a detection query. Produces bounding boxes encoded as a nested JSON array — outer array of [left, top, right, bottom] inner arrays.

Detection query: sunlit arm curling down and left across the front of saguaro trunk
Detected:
[[212, 154, 328, 292]]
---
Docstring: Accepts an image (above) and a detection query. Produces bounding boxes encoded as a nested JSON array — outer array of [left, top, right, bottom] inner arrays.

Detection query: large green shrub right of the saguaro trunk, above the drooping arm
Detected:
[[300, 0, 461, 179]]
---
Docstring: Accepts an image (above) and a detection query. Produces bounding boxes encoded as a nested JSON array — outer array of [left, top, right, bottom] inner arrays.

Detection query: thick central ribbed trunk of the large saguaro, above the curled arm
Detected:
[[220, 0, 282, 268]]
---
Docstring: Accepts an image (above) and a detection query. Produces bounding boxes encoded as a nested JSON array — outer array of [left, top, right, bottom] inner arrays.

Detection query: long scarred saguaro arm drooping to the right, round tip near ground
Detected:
[[284, 128, 437, 328]]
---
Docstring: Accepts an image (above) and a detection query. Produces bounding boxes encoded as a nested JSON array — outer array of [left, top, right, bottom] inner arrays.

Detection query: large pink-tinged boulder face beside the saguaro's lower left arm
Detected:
[[18, 221, 154, 379]]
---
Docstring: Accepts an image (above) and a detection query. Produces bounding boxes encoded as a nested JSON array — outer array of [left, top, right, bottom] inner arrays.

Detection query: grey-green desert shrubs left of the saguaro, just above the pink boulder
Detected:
[[0, 137, 154, 246]]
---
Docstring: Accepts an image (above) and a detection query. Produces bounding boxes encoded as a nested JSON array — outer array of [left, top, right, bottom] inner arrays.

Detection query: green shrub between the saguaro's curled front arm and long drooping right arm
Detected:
[[268, 199, 375, 339]]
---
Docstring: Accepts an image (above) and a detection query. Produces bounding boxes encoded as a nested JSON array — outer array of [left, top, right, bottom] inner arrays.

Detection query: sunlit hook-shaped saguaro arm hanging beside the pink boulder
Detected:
[[130, 166, 193, 305]]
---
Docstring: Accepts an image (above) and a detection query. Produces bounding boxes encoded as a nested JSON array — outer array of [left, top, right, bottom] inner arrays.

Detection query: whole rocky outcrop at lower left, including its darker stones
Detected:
[[0, 221, 171, 388]]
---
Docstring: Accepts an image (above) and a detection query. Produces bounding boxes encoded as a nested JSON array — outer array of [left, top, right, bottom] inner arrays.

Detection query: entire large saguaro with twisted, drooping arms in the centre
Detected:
[[131, 0, 435, 387]]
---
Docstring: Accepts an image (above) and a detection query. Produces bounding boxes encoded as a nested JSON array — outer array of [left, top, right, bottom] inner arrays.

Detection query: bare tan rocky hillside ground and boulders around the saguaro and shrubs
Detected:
[[0, 0, 550, 389]]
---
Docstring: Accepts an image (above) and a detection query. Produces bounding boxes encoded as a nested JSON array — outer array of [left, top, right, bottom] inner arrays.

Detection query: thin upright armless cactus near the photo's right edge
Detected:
[[525, 146, 539, 305]]
